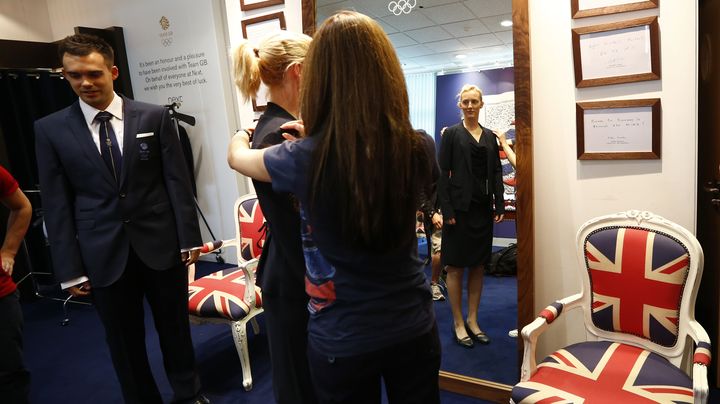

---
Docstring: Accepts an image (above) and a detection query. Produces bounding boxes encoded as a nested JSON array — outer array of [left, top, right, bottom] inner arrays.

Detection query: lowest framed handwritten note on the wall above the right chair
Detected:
[[576, 98, 661, 160]]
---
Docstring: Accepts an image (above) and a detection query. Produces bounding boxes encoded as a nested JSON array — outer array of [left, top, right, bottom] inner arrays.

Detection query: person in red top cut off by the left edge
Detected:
[[0, 166, 32, 404]]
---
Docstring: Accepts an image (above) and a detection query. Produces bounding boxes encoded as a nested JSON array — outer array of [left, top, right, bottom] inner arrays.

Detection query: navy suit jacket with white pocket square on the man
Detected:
[[35, 98, 202, 287]]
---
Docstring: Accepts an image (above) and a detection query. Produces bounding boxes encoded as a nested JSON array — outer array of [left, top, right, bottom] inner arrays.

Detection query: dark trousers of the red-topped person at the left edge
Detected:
[[0, 291, 30, 404]]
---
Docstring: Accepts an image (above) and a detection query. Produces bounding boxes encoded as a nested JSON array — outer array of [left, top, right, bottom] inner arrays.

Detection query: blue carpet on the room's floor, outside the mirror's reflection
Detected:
[[23, 263, 492, 404]]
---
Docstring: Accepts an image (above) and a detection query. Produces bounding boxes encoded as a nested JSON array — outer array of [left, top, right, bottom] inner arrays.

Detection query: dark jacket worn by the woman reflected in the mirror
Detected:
[[438, 123, 505, 220]]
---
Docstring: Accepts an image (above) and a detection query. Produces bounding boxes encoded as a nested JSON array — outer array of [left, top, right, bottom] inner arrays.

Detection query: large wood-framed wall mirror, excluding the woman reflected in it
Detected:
[[302, 0, 535, 402]]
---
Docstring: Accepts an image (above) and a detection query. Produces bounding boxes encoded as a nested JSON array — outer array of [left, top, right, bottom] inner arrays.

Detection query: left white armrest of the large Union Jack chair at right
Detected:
[[520, 293, 582, 382]]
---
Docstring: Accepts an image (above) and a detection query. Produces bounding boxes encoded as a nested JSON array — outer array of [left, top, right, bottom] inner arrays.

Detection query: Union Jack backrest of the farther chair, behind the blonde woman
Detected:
[[235, 194, 268, 263]]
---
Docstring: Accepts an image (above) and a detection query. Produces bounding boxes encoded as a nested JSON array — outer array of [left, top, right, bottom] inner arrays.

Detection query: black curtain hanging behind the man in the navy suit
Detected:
[[0, 69, 77, 296]]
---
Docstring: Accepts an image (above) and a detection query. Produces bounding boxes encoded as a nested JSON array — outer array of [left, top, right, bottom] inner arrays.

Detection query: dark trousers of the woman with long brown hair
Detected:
[[308, 324, 440, 404]]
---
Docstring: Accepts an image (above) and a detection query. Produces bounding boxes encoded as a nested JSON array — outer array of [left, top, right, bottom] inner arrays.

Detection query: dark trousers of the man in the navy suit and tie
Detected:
[[92, 249, 200, 404]]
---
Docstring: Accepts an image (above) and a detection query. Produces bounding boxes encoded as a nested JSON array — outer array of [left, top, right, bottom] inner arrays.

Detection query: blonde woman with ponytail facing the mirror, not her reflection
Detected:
[[233, 31, 316, 404]]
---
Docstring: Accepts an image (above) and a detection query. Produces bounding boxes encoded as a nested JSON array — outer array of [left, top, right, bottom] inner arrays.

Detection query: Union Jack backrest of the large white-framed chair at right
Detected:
[[577, 211, 703, 366]]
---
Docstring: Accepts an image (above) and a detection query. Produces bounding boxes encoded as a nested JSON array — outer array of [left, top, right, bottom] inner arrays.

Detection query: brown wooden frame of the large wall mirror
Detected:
[[301, 0, 535, 403]]
